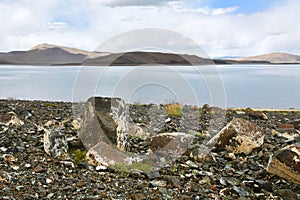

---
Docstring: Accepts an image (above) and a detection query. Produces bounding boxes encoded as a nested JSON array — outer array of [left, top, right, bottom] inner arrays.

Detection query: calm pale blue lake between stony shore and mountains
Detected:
[[0, 65, 300, 109]]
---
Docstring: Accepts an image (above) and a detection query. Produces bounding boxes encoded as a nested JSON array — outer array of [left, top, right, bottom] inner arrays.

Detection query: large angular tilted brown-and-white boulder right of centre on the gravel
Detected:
[[206, 118, 265, 155]]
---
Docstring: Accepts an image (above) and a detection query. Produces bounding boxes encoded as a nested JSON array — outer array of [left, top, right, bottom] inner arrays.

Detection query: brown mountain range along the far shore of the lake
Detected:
[[0, 44, 300, 66]]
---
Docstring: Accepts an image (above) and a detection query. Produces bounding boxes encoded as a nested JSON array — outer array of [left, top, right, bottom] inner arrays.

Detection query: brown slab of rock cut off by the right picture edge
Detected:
[[267, 143, 300, 185]]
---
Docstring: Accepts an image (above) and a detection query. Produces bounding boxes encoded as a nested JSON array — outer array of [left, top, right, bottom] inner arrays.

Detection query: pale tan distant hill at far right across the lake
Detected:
[[234, 53, 300, 64]]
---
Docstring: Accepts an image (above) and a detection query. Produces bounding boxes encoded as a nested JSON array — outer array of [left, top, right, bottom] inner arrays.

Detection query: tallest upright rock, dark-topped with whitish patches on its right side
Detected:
[[79, 97, 128, 150]]
